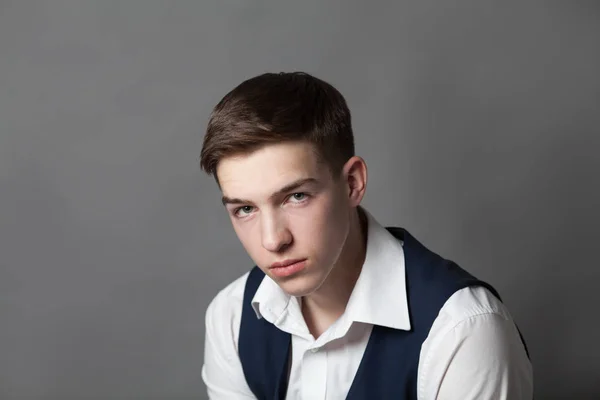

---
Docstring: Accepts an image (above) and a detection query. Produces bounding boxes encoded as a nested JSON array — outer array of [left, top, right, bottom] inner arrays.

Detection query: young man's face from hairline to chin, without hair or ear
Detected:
[[217, 142, 352, 296]]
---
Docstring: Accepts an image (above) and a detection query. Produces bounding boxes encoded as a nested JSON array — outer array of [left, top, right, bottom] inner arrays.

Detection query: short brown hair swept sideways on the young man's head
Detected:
[[200, 72, 354, 178]]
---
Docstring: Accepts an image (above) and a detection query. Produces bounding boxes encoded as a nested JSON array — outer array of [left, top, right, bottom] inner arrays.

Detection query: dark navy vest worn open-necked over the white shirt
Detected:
[[238, 228, 528, 400]]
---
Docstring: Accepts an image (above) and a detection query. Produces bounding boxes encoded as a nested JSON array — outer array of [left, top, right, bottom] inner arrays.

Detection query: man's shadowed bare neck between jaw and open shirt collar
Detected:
[[302, 207, 367, 338]]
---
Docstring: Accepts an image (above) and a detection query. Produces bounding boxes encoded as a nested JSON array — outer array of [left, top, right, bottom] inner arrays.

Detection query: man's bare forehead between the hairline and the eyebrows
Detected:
[[217, 142, 327, 199]]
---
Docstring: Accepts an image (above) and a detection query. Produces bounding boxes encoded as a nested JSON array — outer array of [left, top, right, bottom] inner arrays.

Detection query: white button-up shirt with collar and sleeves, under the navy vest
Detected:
[[202, 212, 533, 400]]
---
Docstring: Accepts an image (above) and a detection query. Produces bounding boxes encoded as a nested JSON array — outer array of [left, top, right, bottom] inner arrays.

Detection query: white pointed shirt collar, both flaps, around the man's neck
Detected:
[[252, 208, 411, 330]]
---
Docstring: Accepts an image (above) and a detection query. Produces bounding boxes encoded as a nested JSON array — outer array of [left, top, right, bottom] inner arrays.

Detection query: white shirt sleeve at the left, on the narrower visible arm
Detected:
[[202, 276, 256, 400]]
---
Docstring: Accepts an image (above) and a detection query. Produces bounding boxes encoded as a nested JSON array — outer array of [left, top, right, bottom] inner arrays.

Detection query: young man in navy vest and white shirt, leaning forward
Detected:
[[201, 73, 533, 400]]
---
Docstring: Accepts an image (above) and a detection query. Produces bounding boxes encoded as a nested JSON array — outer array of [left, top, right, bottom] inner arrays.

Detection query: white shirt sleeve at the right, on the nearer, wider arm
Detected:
[[419, 288, 533, 400]]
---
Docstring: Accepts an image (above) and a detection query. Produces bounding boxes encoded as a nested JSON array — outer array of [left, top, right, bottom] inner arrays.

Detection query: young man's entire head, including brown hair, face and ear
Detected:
[[201, 73, 366, 296]]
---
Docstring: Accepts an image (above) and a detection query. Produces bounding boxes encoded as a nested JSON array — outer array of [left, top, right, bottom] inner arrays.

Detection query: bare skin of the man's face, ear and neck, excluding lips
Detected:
[[217, 142, 367, 337]]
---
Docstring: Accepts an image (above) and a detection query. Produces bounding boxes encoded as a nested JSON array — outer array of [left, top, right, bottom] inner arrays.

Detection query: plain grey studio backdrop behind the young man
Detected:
[[0, 0, 600, 399]]
